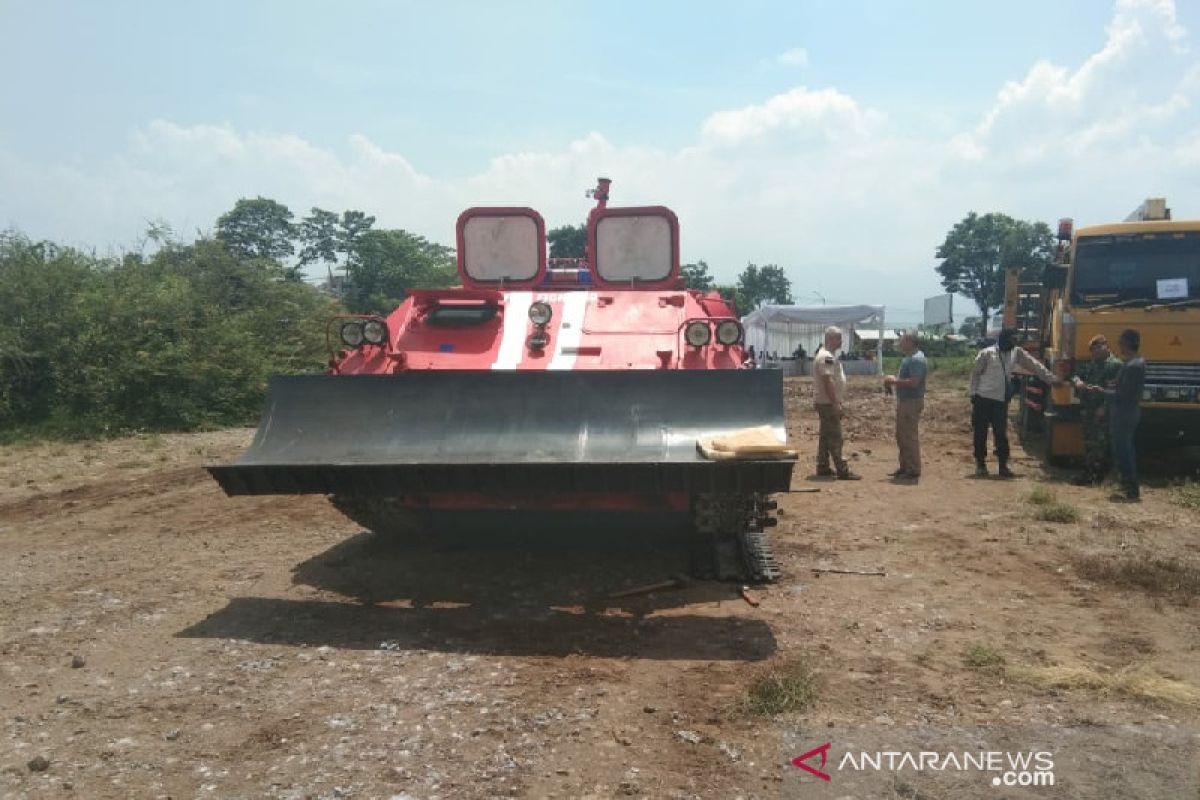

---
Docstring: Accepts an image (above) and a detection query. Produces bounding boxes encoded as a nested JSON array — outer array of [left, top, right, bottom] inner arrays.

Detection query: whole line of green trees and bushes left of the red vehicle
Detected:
[[0, 197, 457, 439]]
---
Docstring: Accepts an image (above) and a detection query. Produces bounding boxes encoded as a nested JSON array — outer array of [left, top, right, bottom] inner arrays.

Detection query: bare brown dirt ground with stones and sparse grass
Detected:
[[0, 379, 1200, 800]]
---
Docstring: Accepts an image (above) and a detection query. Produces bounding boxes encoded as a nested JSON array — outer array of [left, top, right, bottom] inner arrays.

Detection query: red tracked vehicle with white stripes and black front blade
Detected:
[[209, 179, 793, 581]]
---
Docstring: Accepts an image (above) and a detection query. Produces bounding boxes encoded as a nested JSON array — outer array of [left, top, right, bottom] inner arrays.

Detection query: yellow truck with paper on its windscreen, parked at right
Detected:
[[1003, 198, 1200, 462]]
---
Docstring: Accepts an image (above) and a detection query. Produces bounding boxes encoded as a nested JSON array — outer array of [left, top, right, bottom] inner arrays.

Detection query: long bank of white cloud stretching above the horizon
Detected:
[[0, 0, 1200, 320]]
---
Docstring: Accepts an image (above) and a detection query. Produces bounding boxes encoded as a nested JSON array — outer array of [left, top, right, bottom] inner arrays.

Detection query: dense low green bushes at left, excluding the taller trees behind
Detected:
[[0, 231, 335, 438]]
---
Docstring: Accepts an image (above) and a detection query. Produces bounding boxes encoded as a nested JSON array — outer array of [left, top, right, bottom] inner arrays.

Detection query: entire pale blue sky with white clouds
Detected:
[[0, 0, 1200, 321]]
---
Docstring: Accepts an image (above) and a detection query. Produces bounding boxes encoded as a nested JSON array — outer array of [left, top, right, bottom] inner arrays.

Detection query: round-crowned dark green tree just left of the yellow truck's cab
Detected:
[[935, 211, 1055, 336]]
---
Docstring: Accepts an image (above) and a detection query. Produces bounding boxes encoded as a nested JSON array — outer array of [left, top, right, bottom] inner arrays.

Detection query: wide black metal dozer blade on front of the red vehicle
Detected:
[[208, 369, 793, 495]]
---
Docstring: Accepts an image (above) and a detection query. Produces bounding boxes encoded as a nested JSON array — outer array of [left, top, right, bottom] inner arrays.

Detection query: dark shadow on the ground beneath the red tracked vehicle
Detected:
[[178, 519, 776, 661]]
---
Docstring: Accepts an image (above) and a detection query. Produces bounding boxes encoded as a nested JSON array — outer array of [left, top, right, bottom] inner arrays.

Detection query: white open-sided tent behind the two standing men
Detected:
[[742, 306, 883, 374]]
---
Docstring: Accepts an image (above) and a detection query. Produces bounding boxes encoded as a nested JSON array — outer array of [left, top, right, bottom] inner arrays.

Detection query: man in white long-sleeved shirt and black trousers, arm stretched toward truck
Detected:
[[968, 327, 1061, 477]]
